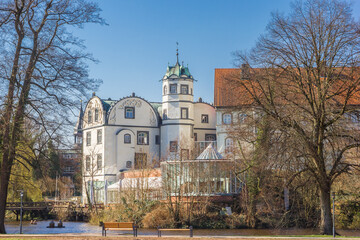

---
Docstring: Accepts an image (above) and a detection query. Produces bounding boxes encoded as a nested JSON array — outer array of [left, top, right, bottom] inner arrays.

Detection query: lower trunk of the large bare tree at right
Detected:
[[320, 183, 332, 235]]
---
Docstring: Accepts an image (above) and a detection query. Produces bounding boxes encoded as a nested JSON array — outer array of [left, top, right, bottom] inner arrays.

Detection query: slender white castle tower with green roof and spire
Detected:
[[161, 49, 194, 160]]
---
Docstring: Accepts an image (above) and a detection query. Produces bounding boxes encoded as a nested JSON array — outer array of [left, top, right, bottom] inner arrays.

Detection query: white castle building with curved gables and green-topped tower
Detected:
[[75, 54, 216, 202]]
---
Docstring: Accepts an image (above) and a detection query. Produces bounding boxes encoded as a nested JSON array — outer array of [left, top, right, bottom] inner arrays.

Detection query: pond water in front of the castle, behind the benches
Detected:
[[5, 221, 360, 236]]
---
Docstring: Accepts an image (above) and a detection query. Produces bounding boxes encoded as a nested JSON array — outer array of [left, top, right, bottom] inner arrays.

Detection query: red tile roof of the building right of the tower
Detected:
[[214, 68, 360, 107]]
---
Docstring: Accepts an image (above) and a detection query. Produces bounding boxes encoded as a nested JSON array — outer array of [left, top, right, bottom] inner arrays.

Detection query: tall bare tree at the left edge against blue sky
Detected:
[[0, 0, 104, 233]]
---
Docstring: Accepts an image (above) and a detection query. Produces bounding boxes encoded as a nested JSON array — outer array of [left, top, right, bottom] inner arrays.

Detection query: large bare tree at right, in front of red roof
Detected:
[[232, 0, 360, 234]]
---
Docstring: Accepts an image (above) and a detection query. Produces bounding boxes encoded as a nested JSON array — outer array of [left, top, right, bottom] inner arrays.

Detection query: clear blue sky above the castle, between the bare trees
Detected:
[[76, 0, 360, 103]]
